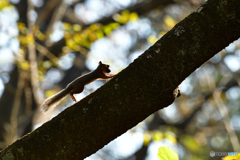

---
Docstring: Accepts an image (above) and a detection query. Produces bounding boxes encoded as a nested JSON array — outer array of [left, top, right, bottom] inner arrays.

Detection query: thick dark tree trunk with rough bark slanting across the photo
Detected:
[[0, 0, 240, 160]]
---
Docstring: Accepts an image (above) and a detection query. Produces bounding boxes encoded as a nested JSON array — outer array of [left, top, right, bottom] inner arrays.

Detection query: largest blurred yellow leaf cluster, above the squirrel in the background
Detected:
[[64, 10, 138, 53]]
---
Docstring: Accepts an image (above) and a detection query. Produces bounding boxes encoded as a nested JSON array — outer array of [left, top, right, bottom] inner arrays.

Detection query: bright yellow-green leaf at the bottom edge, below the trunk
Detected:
[[158, 147, 179, 160]]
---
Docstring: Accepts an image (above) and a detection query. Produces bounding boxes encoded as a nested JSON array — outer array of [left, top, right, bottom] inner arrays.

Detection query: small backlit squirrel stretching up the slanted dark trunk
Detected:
[[40, 61, 115, 113]]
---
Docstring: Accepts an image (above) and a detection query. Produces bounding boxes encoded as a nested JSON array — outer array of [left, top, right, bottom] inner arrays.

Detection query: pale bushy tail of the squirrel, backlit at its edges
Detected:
[[40, 87, 71, 113]]
